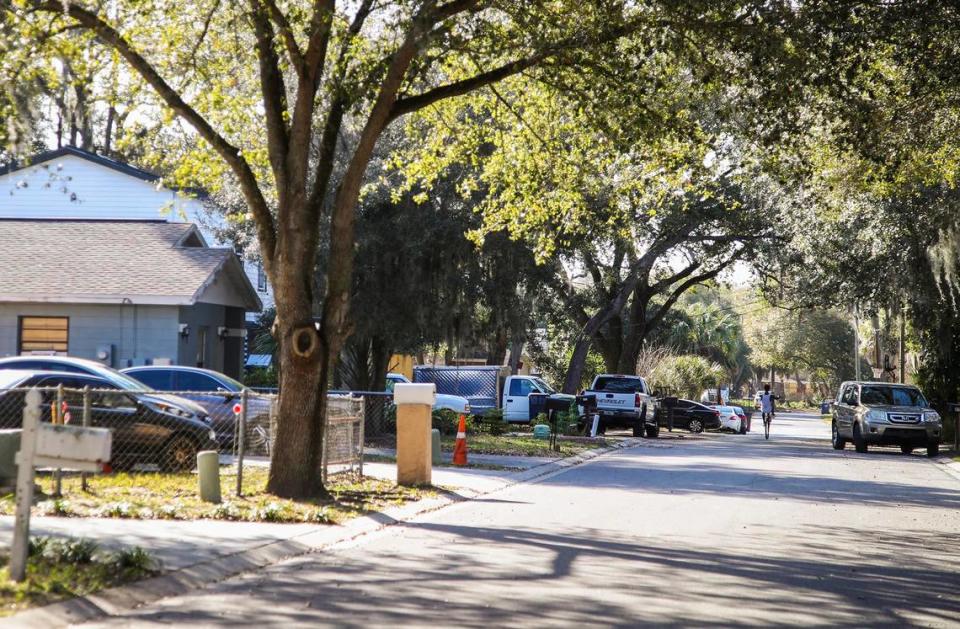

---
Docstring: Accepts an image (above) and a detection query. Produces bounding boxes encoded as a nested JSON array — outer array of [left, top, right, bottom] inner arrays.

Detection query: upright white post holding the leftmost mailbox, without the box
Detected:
[[10, 389, 40, 582]]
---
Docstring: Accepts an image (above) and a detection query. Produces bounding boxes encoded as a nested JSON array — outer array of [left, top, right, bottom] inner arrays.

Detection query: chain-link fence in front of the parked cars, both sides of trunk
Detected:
[[0, 385, 368, 498]]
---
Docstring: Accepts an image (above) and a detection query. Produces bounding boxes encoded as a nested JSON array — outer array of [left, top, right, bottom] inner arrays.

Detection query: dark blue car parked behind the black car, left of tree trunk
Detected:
[[120, 365, 271, 454]]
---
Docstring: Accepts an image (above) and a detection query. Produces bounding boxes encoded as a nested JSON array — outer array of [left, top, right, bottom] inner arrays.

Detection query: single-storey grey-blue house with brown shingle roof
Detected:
[[0, 221, 262, 376]]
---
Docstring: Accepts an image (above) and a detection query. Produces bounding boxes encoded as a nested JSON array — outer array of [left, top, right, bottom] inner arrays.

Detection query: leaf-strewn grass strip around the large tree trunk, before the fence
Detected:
[[0, 467, 430, 524]]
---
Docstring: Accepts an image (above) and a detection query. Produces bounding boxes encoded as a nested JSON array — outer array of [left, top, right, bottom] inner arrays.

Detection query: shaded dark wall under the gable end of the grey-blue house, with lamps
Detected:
[[176, 303, 244, 378]]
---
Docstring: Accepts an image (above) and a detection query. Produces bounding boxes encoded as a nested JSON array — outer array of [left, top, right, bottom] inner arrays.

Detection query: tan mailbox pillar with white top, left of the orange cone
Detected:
[[393, 383, 437, 485]]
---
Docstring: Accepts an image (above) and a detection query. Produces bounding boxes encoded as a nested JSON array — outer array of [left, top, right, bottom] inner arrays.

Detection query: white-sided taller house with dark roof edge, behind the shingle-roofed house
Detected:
[[0, 146, 273, 320]]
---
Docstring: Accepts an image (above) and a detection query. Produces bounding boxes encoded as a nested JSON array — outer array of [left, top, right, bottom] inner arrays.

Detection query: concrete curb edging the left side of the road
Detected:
[[0, 438, 642, 629]]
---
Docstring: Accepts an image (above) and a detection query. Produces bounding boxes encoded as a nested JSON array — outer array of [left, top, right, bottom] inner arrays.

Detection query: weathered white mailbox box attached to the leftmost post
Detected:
[[33, 424, 112, 472]]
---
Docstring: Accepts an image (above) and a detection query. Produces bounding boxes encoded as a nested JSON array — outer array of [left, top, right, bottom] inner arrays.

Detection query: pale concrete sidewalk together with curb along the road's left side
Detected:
[[0, 439, 647, 628]]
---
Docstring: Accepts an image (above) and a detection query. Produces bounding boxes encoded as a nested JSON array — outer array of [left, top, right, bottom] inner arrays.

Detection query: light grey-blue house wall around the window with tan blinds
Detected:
[[0, 303, 179, 368]]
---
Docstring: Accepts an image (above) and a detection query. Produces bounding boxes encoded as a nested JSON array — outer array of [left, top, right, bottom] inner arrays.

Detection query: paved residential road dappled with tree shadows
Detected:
[[77, 415, 960, 627]]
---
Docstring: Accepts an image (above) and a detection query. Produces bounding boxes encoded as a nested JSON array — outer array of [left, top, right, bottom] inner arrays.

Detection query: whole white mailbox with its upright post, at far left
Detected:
[[10, 389, 111, 581]]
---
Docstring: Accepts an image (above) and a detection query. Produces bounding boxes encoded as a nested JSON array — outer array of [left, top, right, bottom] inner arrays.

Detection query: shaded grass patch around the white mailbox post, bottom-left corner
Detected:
[[0, 537, 156, 616]]
